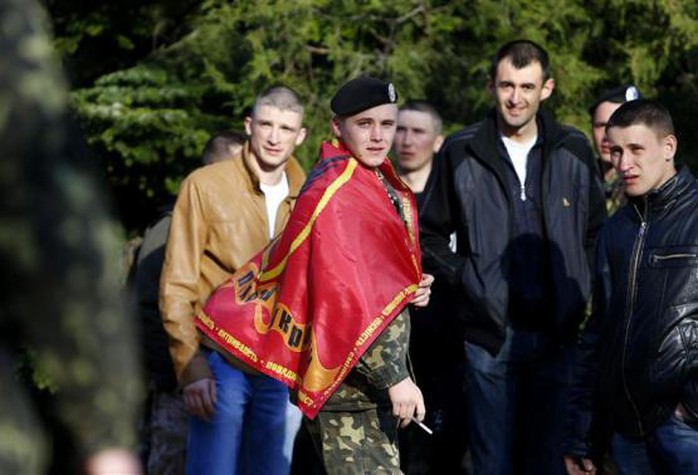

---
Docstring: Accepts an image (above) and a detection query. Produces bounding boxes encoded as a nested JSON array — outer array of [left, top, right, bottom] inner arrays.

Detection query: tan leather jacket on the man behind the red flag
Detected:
[[159, 142, 305, 386]]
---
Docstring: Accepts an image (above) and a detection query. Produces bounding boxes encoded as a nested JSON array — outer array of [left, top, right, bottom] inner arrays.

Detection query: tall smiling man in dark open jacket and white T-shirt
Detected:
[[420, 40, 606, 474]]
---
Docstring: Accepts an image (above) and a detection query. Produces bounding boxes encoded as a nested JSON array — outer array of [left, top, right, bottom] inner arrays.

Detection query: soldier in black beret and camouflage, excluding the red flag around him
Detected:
[[304, 77, 433, 474]]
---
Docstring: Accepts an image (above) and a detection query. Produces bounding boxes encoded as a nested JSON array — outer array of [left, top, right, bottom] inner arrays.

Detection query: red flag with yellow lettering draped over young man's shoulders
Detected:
[[197, 142, 422, 418]]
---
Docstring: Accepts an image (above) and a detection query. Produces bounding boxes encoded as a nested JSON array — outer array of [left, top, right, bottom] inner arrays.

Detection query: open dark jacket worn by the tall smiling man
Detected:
[[420, 110, 606, 354]]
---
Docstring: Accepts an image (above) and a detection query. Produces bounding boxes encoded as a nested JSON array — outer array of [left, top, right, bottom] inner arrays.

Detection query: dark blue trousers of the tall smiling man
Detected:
[[466, 329, 572, 475]]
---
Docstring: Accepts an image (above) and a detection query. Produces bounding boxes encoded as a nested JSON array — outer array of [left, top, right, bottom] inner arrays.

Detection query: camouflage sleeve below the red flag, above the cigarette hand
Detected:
[[354, 307, 410, 389]]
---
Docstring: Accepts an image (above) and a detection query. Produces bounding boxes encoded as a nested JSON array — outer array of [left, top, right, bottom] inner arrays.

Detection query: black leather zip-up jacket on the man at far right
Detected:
[[565, 167, 698, 456]]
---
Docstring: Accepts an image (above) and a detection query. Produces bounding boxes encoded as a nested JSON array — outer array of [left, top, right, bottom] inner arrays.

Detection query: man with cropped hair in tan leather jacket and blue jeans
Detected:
[[160, 87, 306, 475]]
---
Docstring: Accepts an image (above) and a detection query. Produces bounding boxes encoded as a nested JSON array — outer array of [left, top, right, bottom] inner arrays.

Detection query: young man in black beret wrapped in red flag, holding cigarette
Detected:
[[197, 76, 433, 474]]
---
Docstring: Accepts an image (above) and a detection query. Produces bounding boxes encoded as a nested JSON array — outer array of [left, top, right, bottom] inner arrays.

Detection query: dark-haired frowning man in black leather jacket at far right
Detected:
[[565, 99, 698, 475]]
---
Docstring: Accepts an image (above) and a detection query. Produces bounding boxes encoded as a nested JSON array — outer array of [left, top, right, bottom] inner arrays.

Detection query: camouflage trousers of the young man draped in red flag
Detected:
[[303, 408, 402, 475]]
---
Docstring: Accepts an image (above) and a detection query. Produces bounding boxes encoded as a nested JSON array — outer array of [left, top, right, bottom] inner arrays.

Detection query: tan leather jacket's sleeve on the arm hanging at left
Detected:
[[160, 180, 212, 386]]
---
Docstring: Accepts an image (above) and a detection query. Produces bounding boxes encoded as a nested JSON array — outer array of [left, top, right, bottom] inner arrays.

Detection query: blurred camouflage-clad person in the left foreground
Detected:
[[0, 0, 141, 474]]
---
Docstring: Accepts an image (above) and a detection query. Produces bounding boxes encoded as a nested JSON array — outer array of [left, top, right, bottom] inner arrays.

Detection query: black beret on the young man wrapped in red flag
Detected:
[[330, 76, 397, 117]]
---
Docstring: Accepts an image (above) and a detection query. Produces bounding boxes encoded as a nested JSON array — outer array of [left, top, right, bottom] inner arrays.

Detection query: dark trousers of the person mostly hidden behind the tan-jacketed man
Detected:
[[143, 390, 189, 475]]
